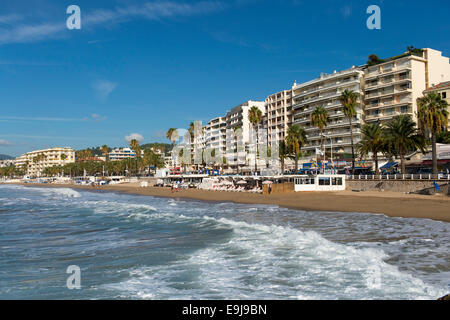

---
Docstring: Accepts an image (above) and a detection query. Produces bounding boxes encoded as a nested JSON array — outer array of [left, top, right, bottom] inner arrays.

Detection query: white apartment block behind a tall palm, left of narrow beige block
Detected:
[[225, 100, 266, 172]]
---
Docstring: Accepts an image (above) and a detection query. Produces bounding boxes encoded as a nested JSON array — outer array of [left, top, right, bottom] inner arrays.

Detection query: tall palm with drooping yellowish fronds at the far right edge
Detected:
[[417, 92, 448, 176]]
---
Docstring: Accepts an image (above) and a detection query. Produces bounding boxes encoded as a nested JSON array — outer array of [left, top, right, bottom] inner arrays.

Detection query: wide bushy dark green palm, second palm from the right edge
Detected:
[[384, 114, 424, 174]]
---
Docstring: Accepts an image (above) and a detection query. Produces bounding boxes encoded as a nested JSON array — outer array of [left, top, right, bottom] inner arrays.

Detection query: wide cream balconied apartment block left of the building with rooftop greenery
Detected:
[[292, 67, 364, 154]]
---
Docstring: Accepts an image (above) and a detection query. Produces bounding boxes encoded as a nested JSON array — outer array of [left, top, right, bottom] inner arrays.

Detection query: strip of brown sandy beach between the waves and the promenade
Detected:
[[3, 183, 450, 222]]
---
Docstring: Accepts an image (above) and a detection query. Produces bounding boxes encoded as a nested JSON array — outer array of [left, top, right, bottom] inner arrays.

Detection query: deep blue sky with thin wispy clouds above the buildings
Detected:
[[0, 0, 450, 156]]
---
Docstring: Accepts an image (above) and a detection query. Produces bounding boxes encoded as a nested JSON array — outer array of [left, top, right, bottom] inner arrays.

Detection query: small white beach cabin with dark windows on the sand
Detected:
[[294, 174, 345, 192]]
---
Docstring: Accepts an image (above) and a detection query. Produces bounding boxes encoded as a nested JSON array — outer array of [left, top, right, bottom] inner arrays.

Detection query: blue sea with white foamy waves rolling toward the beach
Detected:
[[0, 185, 450, 299]]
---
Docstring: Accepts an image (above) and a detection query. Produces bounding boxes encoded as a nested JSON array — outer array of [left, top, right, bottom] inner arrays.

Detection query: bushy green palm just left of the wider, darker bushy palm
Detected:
[[356, 123, 385, 174]]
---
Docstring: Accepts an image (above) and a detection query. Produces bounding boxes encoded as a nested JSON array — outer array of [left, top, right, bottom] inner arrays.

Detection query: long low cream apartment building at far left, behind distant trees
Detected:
[[14, 147, 75, 176]]
